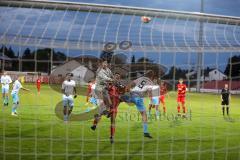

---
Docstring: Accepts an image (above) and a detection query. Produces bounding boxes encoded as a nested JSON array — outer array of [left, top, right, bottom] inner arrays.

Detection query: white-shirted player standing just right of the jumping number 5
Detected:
[[148, 78, 160, 119]]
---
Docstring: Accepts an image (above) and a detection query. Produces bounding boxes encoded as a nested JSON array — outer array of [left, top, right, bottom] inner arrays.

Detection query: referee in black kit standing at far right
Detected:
[[221, 84, 230, 116]]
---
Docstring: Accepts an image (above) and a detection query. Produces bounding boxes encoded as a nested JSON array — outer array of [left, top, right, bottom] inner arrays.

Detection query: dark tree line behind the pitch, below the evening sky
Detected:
[[0, 46, 240, 80]]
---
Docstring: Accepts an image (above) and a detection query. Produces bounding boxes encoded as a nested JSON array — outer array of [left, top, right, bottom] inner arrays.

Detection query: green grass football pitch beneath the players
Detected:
[[0, 85, 240, 160]]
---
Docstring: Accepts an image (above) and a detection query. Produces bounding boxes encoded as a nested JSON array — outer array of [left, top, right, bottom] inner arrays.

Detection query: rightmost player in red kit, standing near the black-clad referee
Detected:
[[177, 78, 187, 115]]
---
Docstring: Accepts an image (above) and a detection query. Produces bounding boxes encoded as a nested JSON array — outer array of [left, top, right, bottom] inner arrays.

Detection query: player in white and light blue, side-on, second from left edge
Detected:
[[11, 77, 29, 116]]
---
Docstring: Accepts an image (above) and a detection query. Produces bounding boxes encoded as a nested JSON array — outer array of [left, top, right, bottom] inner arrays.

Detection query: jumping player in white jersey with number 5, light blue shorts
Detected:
[[121, 72, 153, 138]]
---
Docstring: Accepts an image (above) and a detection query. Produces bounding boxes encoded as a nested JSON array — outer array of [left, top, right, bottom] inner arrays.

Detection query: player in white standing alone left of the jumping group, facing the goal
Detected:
[[62, 73, 77, 122]]
